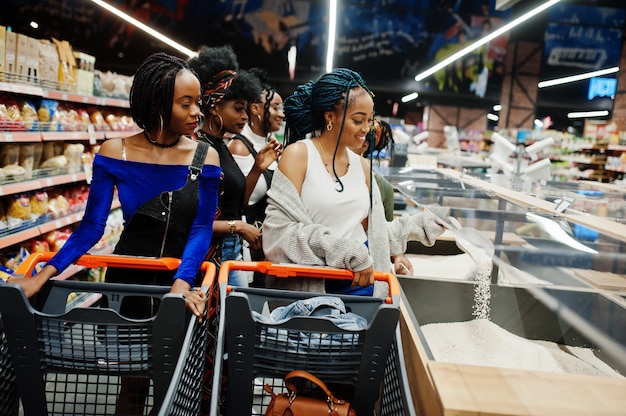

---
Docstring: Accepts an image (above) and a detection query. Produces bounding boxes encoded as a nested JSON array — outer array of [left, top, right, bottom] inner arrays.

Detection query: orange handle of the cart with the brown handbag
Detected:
[[218, 260, 400, 297]]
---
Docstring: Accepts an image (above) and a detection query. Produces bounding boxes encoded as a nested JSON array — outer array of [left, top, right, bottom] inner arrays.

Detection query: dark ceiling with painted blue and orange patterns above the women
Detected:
[[0, 0, 626, 118]]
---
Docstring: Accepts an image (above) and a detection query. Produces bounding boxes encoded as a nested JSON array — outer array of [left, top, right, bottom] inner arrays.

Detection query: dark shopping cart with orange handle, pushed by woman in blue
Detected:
[[0, 253, 216, 416]]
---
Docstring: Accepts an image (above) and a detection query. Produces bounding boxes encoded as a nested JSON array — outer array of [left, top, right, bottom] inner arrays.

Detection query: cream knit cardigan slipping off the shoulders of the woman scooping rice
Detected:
[[263, 169, 444, 293]]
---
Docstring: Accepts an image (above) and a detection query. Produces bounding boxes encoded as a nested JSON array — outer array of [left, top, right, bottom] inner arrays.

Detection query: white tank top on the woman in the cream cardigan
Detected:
[[300, 139, 370, 243]]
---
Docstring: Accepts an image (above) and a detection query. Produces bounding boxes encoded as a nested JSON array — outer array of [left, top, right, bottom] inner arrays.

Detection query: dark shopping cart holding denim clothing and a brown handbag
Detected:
[[205, 261, 415, 415]]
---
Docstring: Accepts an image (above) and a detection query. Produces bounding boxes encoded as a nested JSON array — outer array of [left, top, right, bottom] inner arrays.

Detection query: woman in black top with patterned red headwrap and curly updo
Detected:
[[189, 46, 280, 286]]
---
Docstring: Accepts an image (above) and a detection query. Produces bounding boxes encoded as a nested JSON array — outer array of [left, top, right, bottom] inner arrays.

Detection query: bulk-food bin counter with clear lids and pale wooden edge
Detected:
[[380, 167, 626, 415]]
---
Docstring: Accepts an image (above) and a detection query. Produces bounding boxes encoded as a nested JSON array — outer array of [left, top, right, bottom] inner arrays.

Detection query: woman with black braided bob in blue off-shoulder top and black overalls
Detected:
[[11, 53, 222, 414]]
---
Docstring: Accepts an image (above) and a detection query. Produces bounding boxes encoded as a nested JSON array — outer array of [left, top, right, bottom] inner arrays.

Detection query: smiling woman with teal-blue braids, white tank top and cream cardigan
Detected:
[[263, 68, 443, 296]]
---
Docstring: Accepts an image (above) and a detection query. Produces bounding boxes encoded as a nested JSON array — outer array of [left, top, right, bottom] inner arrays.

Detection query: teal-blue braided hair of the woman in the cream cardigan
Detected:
[[283, 68, 373, 192]]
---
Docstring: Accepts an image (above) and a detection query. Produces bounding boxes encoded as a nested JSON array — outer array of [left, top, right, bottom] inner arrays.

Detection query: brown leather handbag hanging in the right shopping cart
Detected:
[[265, 370, 356, 416]]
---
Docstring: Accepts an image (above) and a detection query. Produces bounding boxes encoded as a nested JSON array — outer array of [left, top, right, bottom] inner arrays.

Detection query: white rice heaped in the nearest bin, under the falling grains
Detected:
[[420, 319, 622, 377]]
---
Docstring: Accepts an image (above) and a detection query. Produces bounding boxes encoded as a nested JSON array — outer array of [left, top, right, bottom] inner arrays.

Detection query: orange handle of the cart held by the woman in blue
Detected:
[[15, 251, 216, 286]]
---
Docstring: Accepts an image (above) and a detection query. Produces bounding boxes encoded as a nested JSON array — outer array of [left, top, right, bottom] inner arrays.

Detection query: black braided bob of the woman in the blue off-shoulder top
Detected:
[[129, 52, 197, 131]]
